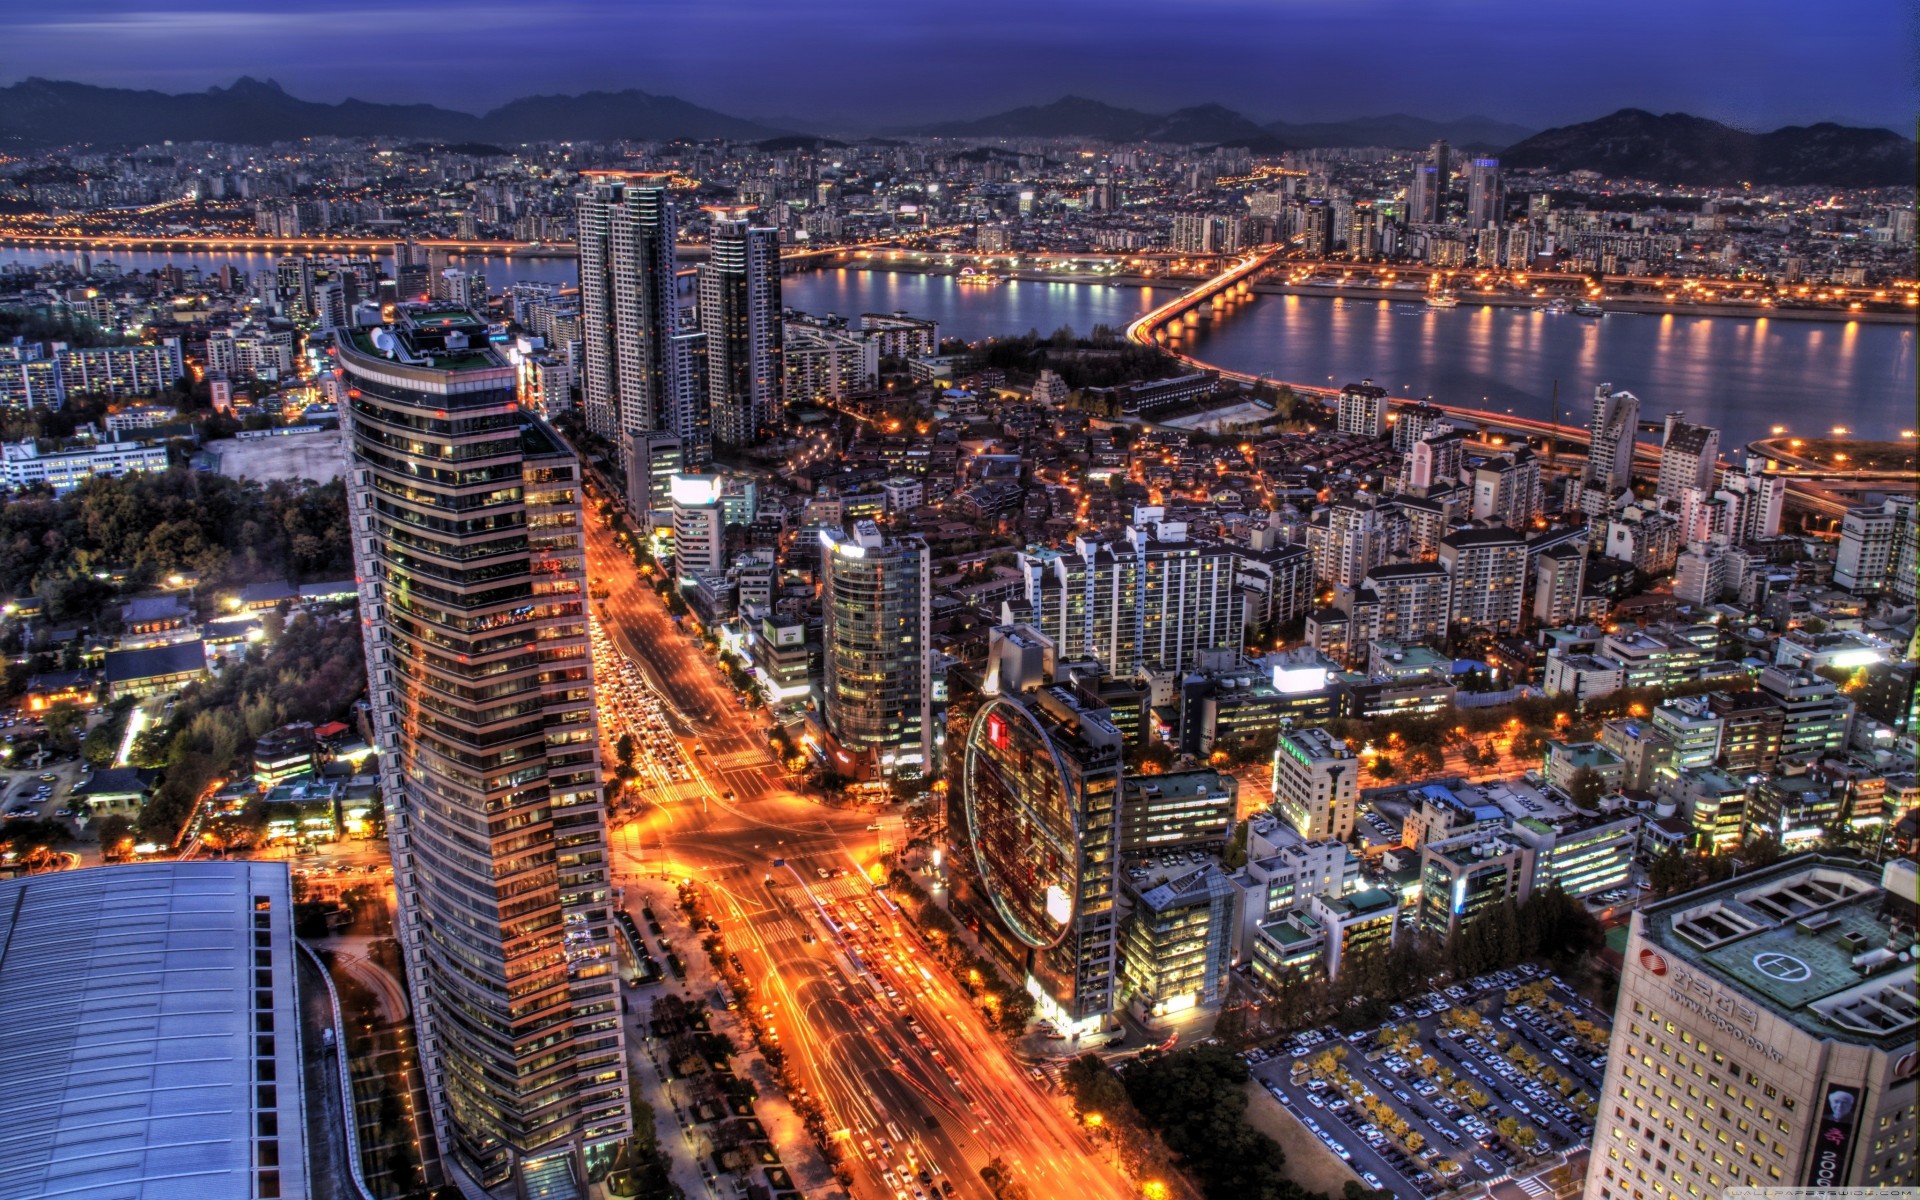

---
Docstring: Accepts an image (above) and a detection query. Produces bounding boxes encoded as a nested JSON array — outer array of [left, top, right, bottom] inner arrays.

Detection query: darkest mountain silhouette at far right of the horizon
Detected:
[[1500, 108, 1916, 188]]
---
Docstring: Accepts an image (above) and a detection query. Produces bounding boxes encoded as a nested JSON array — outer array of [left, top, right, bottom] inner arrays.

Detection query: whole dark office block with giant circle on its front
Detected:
[[954, 687, 1121, 1033]]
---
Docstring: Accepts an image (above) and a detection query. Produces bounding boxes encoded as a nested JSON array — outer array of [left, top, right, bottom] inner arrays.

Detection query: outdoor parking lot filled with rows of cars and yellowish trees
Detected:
[[1248, 964, 1607, 1196]]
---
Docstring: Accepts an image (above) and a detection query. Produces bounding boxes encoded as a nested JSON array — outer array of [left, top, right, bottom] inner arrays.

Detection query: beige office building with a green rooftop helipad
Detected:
[[1586, 854, 1916, 1200]]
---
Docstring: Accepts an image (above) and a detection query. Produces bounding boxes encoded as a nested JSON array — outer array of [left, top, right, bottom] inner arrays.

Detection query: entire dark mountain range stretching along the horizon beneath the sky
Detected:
[[0, 77, 1914, 188]]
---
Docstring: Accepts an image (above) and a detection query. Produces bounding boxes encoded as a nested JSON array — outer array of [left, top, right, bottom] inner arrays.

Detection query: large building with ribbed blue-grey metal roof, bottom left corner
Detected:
[[0, 860, 311, 1200]]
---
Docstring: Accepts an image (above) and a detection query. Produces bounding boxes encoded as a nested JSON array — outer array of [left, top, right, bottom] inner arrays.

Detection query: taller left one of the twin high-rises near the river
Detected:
[[576, 171, 708, 470]]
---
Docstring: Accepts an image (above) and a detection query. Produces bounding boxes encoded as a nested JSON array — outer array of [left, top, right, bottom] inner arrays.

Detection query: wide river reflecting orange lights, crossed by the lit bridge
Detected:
[[0, 246, 1920, 447]]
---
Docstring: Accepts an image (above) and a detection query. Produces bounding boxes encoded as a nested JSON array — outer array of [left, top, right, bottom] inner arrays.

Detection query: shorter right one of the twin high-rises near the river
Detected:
[[699, 217, 781, 445]]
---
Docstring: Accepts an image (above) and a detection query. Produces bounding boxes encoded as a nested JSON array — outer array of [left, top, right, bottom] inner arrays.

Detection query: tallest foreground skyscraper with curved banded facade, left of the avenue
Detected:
[[336, 309, 632, 1194]]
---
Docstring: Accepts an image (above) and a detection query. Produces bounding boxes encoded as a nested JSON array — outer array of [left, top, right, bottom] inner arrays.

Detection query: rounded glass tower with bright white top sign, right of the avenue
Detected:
[[820, 520, 933, 778]]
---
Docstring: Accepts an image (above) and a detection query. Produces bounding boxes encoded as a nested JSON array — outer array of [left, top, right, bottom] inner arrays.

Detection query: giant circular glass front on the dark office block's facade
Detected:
[[962, 697, 1081, 948]]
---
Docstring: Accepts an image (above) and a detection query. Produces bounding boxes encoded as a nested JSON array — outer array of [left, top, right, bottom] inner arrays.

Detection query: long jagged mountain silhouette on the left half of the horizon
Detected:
[[0, 77, 783, 148]]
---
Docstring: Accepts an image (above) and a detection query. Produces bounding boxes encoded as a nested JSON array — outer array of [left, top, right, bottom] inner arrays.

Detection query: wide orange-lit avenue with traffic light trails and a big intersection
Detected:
[[588, 491, 1135, 1200]]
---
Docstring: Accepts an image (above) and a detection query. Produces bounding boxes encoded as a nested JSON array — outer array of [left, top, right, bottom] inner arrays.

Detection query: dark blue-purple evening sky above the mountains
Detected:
[[0, 0, 1920, 132]]
